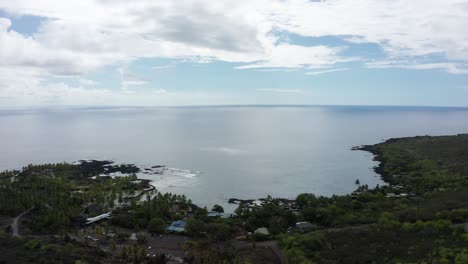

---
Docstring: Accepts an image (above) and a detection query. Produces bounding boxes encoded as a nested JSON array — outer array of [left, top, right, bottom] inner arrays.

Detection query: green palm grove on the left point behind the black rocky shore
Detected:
[[0, 163, 146, 232]]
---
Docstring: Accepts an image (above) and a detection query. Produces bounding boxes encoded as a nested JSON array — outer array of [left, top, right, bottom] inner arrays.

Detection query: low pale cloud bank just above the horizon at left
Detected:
[[0, 79, 239, 108]]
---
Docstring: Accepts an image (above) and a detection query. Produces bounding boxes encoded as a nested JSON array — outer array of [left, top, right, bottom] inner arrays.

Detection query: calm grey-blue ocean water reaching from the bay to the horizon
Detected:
[[0, 106, 468, 210]]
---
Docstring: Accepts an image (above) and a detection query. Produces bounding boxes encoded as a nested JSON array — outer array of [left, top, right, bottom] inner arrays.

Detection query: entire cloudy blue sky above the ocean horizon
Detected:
[[0, 0, 468, 107]]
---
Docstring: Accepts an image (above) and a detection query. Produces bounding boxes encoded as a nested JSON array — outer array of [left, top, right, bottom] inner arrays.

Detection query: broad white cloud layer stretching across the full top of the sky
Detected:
[[0, 0, 468, 105]]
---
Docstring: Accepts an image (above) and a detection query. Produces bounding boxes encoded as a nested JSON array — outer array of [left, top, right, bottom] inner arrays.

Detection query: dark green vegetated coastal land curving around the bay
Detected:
[[0, 134, 468, 263]]
